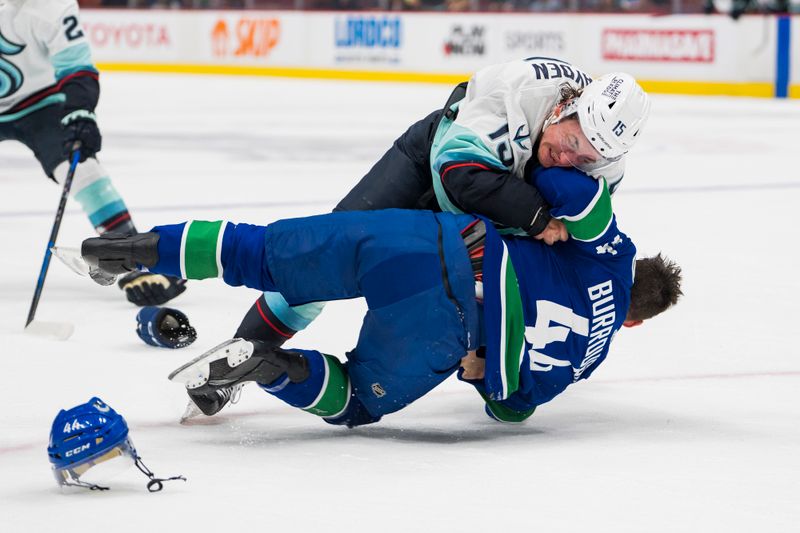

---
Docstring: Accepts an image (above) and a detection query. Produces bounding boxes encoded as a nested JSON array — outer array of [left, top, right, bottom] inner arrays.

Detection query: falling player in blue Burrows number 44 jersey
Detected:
[[82, 168, 680, 426]]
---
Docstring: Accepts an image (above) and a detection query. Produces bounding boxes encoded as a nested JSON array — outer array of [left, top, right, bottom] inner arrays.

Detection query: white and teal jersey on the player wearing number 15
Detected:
[[431, 57, 624, 212]]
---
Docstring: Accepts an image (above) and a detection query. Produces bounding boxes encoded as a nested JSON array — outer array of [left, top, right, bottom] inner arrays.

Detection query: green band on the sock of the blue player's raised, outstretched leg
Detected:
[[181, 220, 224, 279]]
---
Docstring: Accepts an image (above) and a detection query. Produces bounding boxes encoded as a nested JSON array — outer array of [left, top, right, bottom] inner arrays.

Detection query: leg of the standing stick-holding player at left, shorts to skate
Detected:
[[15, 105, 186, 305]]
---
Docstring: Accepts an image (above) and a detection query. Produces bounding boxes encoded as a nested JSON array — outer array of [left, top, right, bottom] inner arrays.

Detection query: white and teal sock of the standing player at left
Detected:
[[54, 157, 136, 234]]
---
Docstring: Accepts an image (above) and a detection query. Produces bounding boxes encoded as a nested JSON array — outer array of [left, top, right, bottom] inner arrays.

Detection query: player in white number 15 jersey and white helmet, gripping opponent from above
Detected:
[[228, 61, 650, 394]]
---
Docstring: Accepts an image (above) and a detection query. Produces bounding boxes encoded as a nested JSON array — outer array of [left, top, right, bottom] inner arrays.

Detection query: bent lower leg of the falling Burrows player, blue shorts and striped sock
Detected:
[[260, 284, 474, 427]]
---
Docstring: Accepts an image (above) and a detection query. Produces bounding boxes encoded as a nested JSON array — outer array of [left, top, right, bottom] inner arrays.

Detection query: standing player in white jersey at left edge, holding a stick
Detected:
[[0, 0, 185, 305]]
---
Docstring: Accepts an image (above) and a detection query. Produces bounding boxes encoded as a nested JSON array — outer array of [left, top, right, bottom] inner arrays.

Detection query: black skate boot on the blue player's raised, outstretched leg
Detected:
[[81, 232, 160, 275]]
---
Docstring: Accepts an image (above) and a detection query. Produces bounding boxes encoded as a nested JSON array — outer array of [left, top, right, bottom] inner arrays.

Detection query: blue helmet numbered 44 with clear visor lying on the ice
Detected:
[[47, 396, 185, 492]]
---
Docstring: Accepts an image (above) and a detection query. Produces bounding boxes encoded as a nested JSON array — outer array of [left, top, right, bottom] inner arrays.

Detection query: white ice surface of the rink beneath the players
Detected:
[[0, 74, 800, 533]]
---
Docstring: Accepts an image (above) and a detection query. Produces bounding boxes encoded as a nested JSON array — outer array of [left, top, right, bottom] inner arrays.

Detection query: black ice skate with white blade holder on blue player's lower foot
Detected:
[[169, 339, 309, 396]]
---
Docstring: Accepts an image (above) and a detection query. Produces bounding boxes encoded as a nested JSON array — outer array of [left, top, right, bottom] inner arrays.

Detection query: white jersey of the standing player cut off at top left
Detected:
[[0, 0, 97, 119]]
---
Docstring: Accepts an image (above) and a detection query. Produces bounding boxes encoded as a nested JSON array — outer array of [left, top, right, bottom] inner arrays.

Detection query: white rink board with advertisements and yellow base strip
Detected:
[[79, 10, 800, 97]]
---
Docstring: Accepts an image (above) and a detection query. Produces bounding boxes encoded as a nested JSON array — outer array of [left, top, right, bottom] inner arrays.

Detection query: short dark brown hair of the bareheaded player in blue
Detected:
[[627, 254, 683, 320]]
